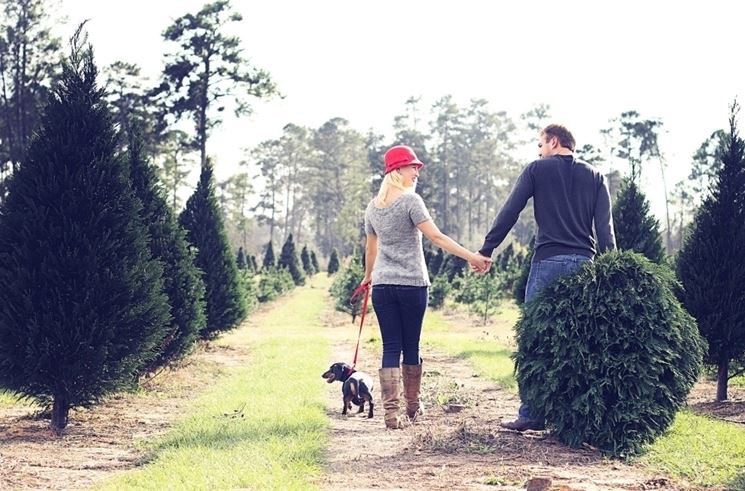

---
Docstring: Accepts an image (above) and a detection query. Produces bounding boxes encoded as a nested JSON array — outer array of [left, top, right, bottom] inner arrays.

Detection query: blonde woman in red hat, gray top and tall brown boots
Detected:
[[362, 145, 491, 428]]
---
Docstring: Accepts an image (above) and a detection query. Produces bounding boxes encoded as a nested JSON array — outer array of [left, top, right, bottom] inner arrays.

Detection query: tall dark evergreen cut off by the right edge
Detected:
[[677, 103, 745, 401]]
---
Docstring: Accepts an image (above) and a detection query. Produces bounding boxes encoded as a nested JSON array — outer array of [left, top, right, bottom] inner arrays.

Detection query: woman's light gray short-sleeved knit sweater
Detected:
[[365, 193, 432, 286]]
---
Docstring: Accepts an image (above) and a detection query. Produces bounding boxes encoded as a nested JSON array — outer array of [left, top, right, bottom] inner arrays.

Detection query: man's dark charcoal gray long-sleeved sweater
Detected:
[[479, 155, 616, 262]]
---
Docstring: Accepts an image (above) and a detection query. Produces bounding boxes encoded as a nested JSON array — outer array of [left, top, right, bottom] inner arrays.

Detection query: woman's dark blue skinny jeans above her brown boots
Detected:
[[372, 285, 428, 368]]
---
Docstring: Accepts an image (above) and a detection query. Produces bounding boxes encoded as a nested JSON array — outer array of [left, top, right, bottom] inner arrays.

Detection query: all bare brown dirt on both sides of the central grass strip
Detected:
[[0, 286, 745, 490]]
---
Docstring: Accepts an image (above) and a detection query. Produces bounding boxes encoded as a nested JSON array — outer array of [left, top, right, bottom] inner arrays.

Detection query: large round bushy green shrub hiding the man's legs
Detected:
[[515, 251, 704, 455]]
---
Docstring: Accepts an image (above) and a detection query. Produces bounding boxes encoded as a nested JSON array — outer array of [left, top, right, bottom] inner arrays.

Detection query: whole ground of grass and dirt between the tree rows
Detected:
[[0, 274, 745, 490]]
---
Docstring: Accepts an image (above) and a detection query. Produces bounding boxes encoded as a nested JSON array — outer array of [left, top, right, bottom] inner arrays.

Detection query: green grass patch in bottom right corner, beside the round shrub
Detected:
[[639, 411, 745, 490]]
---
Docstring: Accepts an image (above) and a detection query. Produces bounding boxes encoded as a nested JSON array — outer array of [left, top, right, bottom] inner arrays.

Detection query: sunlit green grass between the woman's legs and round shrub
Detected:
[[422, 305, 518, 390]]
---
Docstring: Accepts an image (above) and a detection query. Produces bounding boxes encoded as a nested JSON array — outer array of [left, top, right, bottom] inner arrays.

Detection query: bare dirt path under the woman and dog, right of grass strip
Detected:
[[319, 308, 690, 490]]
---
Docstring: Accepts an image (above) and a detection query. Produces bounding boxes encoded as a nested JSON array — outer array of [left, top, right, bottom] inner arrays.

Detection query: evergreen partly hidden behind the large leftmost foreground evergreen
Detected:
[[127, 128, 207, 368]]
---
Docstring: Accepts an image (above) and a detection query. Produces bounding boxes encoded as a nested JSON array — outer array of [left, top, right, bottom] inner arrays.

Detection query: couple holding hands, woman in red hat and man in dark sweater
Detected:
[[362, 125, 615, 431]]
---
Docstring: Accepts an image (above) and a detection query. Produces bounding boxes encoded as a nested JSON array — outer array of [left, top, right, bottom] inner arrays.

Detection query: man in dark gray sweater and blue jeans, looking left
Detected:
[[479, 124, 616, 431]]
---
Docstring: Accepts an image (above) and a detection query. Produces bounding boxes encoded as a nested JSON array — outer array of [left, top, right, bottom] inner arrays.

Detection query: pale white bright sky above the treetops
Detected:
[[59, 0, 745, 219]]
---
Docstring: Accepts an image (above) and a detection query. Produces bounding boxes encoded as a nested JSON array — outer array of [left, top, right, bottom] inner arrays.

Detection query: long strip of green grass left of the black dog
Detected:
[[99, 280, 328, 490]]
